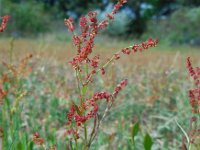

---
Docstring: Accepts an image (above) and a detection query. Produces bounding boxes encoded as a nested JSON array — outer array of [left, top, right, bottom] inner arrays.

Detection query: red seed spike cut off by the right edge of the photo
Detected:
[[187, 57, 200, 113]]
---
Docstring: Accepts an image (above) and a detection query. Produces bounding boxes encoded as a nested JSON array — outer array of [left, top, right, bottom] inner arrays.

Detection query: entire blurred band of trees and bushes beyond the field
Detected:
[[0, 0, 200, 46]]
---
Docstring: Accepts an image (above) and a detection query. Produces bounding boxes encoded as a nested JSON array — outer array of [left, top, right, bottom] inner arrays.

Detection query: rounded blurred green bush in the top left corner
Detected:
[[0, 0, 51, 37]]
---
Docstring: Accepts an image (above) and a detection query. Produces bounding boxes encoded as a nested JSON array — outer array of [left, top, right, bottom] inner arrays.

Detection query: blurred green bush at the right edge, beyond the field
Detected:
[[144, 7, 200, 46]]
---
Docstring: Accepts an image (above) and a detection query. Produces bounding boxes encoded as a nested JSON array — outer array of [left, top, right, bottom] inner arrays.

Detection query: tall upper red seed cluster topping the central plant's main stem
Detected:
[[64, 0, 127, 68]]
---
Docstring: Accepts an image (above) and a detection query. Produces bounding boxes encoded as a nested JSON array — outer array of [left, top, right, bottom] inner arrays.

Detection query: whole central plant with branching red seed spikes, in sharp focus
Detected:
[[64, 0, 158, 149]]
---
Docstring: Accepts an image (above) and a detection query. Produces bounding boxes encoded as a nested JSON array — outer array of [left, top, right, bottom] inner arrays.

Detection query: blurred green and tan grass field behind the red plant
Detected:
[[0, 35, 200, 150]]
